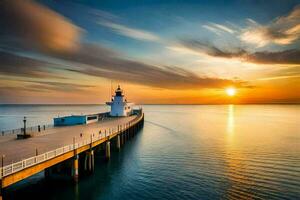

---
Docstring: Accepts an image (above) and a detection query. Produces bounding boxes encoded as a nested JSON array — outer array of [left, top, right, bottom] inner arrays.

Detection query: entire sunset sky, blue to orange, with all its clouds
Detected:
[[0, 0, 300, 104]]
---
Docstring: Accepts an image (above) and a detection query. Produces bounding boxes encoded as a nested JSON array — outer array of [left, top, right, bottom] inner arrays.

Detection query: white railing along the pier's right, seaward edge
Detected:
[[0, 110, 144, 179]]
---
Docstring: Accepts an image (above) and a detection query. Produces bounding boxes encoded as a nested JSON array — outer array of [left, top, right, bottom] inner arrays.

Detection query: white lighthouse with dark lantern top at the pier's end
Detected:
[[106, 85, 133, 117]]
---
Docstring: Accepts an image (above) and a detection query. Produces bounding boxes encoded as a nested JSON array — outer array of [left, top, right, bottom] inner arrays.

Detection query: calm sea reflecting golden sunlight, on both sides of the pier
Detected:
[[0, 105, 300, 200]]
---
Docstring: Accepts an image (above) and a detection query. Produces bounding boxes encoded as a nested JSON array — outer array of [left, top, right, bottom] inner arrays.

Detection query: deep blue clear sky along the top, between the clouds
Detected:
[[41, 0, 299, 48]]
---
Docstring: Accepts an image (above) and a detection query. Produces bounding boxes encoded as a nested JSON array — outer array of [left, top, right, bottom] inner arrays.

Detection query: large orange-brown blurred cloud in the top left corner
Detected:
[[0, 0, 82, 51]]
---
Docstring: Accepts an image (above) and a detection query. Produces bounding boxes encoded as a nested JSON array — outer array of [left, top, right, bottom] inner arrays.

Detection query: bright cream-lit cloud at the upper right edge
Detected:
[[240, 6, 300, 47]]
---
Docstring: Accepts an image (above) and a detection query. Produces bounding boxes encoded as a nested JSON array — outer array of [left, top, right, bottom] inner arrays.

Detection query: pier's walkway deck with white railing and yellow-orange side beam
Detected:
[[0, 111, 144, 199]]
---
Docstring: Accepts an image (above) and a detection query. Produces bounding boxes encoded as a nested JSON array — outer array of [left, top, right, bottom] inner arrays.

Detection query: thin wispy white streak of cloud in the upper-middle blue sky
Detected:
[[98, 21, 160, 41]]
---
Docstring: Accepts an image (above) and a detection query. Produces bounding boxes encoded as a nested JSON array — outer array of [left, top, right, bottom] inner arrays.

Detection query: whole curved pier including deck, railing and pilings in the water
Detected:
[[0, 109, 144, 200]]
